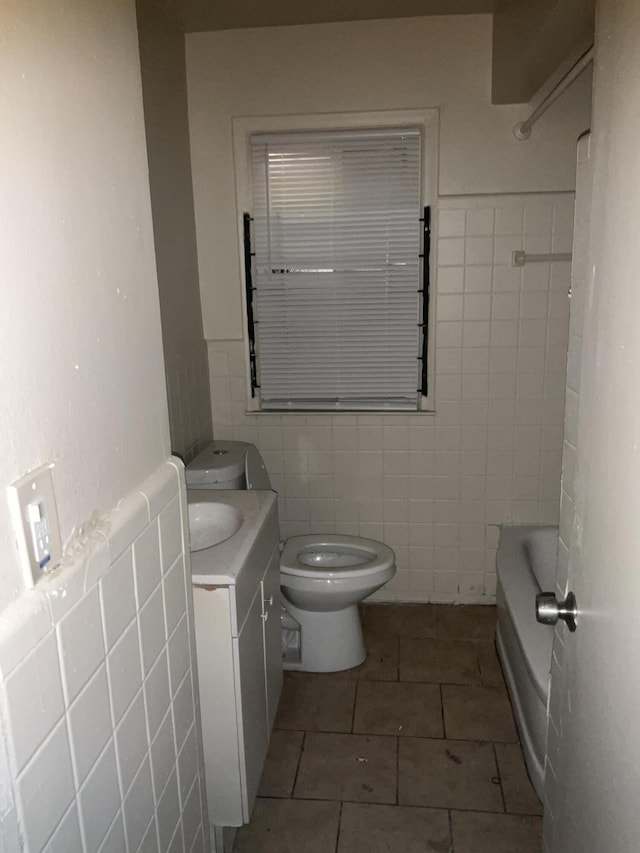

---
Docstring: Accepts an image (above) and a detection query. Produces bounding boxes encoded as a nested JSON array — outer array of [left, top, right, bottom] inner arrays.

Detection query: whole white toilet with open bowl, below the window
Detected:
[[186, 441, 396, 672]]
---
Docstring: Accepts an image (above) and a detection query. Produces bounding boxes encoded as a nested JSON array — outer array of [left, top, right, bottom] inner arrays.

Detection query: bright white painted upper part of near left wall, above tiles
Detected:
[[0, 0, 169, 610]]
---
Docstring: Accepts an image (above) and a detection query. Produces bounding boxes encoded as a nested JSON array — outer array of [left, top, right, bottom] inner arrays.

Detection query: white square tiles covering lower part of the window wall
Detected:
[[209, 193, 573, 603]]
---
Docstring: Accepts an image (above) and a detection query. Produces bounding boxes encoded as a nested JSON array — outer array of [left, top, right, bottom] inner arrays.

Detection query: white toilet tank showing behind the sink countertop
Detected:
[[185, 441, 271, 490]]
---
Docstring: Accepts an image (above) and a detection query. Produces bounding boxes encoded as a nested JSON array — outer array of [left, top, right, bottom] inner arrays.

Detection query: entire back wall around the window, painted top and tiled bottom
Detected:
[[187, 16, 590, 602]]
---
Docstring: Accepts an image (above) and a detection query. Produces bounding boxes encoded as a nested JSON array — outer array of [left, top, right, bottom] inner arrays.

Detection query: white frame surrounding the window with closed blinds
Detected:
[[232, 108, 439, 415]]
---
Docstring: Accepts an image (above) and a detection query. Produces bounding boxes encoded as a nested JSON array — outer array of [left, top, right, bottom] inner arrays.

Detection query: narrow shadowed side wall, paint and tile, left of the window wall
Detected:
[[137, 0, 211, 461]]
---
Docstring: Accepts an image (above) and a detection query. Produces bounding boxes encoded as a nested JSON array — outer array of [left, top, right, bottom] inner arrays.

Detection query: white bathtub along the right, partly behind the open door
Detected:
[[496, 525, 558, 799]]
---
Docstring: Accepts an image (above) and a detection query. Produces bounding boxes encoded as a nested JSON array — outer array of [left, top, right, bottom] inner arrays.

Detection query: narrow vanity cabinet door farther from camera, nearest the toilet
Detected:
[[261, 548, 282, 737]]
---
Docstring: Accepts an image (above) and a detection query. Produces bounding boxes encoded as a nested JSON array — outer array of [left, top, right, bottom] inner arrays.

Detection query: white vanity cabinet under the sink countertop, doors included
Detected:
[[193, 493, 282, 826]]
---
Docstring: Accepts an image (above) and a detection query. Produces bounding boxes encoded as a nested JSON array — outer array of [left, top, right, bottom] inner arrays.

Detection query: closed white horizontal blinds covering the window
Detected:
[[251, 128, 421, 409]]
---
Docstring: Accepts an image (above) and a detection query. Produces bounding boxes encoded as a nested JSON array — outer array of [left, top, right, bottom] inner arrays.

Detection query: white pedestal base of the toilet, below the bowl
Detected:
[[282, 598, 367, 672]]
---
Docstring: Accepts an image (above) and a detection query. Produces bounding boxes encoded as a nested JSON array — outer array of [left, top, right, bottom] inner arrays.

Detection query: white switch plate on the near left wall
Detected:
[[8, 464, 62, 587]]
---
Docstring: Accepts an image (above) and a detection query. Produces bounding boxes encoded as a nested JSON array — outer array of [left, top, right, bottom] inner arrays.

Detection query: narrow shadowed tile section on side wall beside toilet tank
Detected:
[[165, 340, 211, 462]]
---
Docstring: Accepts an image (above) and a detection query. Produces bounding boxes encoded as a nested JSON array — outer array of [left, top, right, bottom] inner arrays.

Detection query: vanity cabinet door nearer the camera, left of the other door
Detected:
[[233, 585, 269, 823]]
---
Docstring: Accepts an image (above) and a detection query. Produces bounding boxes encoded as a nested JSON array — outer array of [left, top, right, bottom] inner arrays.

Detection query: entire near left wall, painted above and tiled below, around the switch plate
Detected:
[[0, 0, 208, 853]]
